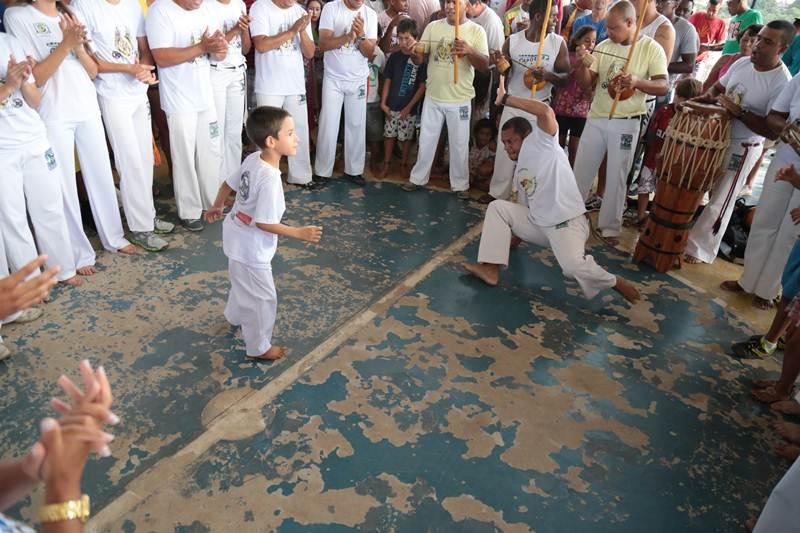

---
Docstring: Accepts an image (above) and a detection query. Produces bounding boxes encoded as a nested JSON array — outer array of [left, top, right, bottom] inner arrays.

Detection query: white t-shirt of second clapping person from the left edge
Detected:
[[4, 5, 100, 122]]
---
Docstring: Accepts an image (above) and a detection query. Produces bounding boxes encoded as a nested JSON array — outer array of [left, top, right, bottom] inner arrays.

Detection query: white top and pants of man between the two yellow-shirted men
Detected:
[[489, 31, 564, 200]]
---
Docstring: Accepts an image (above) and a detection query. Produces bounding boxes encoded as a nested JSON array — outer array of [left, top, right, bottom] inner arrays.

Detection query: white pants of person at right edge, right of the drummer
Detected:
[[739, 149, 800, 300]]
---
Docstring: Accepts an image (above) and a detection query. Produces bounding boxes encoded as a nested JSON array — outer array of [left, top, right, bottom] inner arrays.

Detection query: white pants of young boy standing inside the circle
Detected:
[[225, 259, 278, 357]]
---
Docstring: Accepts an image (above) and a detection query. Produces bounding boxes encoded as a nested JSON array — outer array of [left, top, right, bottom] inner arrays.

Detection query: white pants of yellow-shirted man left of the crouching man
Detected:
[[411, 98, 472, 191]]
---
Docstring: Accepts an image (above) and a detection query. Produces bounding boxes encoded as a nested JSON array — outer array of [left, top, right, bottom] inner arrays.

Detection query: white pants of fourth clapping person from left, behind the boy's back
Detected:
[[167, 108, 222, 220]]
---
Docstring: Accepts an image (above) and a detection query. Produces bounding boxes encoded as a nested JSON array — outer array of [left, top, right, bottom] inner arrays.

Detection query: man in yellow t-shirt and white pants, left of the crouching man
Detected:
[[403, 0, 489, 196]]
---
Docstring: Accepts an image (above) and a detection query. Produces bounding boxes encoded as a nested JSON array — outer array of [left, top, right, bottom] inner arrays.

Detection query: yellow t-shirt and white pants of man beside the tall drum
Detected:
[[575, 37, 667, 237]]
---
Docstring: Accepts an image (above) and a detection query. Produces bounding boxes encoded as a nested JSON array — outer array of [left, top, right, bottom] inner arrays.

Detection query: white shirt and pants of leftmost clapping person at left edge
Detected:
[[0, 33, 75, 281]]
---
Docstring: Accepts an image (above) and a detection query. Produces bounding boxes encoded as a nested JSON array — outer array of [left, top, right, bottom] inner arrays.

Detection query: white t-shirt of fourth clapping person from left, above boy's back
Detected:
[[145, 0, 220, 113]]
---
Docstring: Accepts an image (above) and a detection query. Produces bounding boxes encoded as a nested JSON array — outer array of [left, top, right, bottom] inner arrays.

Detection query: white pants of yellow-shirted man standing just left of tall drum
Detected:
[[575, 117, 641, 237]]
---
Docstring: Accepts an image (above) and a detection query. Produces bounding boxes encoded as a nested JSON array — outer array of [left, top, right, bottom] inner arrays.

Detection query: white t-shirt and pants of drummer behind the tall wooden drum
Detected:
[[686, 57, 790, 264]]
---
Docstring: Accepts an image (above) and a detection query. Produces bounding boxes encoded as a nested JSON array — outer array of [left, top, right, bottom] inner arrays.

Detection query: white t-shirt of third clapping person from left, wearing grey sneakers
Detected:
[[70, 0, 147, 98]]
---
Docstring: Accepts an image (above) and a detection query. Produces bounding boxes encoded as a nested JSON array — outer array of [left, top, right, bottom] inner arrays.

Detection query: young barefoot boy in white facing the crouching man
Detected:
[[206, 107, 322, 361]]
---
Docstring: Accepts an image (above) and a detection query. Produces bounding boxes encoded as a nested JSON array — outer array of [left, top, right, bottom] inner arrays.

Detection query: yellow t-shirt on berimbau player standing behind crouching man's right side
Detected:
[[589, 36, 667, 118]]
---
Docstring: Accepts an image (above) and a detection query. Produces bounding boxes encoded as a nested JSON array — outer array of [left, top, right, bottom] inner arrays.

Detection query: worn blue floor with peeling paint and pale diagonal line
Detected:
[[0, 172, 787, 533]]
